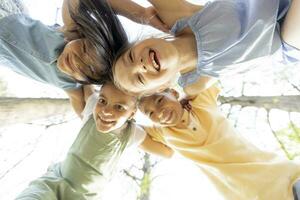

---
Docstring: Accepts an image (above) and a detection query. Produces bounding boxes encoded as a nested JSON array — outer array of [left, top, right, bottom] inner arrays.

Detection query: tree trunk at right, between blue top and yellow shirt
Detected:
[[219, 95, 300, 112]]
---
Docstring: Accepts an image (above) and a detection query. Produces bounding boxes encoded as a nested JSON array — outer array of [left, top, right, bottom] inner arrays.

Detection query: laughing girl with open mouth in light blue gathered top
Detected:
[[113, 0, 300, 93]]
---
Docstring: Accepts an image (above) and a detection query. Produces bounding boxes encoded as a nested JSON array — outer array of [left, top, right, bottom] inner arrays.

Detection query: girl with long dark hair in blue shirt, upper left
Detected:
[[0, 0, 168, 115]]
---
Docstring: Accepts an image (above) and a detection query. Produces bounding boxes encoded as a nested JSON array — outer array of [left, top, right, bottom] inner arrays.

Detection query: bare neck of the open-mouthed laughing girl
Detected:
[[171, 34, 198, 74]]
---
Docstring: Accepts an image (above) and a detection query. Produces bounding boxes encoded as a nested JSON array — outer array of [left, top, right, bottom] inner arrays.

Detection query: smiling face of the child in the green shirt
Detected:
[[93, 83, 136, 133]]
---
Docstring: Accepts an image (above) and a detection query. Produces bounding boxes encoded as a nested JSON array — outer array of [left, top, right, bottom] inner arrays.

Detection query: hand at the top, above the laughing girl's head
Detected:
[[141, 6, 170, 33]]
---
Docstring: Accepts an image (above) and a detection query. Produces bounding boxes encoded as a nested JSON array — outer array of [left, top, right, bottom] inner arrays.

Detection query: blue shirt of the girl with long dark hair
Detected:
[[0, 14, 80, 90]]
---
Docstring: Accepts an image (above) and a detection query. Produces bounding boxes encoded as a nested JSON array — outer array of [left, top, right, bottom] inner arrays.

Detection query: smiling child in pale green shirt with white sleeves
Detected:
[[17, 83, 171, 199]]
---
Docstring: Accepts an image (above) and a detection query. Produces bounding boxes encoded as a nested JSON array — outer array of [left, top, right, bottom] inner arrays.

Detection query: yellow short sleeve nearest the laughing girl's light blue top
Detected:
[[191, 85, 221, 107]]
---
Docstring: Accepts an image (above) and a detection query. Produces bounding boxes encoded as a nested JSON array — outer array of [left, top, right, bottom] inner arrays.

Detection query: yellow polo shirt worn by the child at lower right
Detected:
[[145, 86, 300, 200]]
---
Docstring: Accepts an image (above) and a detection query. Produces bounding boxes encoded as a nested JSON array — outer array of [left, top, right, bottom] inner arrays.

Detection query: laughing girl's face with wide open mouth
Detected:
[[113, 38, 179, 94]]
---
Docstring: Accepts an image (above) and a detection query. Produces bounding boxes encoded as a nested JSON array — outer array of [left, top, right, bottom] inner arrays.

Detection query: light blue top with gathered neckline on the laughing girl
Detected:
[[171, 0, 300, 87]]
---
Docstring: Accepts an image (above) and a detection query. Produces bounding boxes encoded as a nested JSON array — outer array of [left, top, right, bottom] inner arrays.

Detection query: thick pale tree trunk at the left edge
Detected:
[[0, 97, 72, 127]]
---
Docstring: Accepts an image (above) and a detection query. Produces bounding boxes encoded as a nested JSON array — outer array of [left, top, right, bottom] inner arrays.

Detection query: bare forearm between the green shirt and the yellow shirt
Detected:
[[139, 134, 174, 158]]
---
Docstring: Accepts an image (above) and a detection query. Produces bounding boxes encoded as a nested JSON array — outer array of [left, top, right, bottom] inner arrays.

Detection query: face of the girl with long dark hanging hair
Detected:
[[57, 39, 102, 81]]
